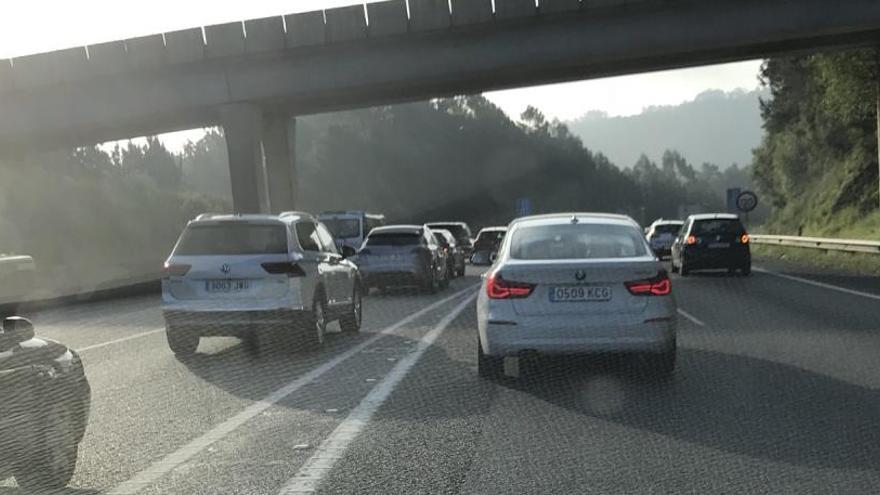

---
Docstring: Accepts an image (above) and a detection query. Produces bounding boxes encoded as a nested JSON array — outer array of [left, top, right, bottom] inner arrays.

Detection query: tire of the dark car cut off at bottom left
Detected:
[[13, 404, 79, 493]]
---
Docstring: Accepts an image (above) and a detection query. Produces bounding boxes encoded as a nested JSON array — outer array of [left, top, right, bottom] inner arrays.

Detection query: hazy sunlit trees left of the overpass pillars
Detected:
[[0, 138, 228, 295]]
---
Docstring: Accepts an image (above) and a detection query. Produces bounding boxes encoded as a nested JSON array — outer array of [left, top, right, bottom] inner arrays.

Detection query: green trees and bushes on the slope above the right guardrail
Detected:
[[754, 49, 880, 239]]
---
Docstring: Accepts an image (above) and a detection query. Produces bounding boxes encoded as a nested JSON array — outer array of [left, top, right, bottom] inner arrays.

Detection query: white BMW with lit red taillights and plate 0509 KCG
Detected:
[[477, 213, 676, 377]]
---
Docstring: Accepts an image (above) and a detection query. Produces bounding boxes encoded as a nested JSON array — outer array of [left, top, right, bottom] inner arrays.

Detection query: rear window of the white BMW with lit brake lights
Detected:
[[510, 224, 647, 260]]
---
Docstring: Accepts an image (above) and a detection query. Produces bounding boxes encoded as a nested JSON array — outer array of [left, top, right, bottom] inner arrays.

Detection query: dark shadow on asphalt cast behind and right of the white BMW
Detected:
[[502, 349, 880, 469]]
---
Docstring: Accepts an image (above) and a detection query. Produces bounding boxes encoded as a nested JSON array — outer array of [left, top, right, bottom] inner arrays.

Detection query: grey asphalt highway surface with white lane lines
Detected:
[[0, 267, 880, 495]]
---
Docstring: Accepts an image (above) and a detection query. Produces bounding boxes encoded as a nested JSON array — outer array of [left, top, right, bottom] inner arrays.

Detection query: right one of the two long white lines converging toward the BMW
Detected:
[[279, 294, 477, 495]]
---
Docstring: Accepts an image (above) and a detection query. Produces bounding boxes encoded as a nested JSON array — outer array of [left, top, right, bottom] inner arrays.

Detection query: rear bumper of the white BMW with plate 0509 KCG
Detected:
[[480, 317, 676, 356]]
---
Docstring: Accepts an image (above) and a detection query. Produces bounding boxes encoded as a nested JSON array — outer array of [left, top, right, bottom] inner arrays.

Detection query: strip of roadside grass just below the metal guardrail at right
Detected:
[[752, 244, 880, 276]]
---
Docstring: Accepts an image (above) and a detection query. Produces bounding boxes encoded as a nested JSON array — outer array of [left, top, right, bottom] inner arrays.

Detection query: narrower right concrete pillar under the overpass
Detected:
[[263, 114, 297, 213]]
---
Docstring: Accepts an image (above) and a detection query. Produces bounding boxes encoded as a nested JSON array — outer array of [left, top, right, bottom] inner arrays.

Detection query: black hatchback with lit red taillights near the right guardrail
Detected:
[[672, 213, 752, 277]]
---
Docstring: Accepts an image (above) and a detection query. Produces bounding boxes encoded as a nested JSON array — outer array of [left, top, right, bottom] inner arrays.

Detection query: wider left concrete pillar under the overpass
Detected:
[[220, 104, 266, 213]]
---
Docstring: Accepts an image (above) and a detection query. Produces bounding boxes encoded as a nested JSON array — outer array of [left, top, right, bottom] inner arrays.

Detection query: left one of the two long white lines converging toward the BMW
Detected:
[[106, 287, 474, 495]]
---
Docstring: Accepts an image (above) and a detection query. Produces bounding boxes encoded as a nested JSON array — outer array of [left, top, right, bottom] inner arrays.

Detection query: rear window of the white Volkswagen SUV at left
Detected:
[[174, 223, 287, 256]]
